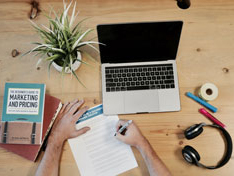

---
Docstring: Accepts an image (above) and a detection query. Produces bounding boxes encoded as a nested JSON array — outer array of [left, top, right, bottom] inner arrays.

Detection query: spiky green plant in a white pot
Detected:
[[24, 2, 99, 84]]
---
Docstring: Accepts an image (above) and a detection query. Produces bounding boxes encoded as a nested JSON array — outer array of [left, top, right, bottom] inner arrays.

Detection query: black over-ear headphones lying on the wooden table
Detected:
[[182, 123, 232, 169]]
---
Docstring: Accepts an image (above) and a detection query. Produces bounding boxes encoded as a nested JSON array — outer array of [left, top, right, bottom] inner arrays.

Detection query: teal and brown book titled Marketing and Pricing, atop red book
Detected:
[[1, 83, 45, 144]]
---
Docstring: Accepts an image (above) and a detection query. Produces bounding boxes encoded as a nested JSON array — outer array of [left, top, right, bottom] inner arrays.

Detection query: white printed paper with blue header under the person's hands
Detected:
[[68, 105, 138, 176]]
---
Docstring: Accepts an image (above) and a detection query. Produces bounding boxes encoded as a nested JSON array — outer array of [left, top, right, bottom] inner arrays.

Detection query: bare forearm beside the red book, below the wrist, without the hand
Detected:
[[36, 136, 63, 176]]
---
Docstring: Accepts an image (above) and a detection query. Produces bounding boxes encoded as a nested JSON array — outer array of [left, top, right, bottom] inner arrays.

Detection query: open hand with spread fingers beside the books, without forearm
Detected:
[[49, 100, 90, 144]]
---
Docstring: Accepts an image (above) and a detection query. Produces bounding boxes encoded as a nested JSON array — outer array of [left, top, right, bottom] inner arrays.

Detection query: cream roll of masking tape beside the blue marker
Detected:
[[198, 83, 219, 101]]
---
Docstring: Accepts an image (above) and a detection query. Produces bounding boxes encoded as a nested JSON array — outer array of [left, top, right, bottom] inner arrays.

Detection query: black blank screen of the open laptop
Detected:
[[97, 21, 183, 63]]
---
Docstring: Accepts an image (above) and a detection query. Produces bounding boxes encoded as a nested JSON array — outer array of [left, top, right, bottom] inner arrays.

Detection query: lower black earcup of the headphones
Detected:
[[182, 145, 200, 165]]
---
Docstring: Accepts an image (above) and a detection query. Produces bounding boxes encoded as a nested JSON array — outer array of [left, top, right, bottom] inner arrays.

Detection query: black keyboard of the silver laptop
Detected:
[[105, 64, 175, 92]]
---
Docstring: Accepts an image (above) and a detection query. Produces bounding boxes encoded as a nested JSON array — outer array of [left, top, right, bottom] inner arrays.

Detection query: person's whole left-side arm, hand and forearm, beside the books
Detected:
[[35, 99, 90, 176]]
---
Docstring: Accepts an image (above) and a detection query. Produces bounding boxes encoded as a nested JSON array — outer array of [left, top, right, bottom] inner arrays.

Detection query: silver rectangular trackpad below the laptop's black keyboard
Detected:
[[124, 90, 159, 113]]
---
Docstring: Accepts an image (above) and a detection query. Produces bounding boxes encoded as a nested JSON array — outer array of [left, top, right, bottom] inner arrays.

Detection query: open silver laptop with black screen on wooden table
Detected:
[[97, 21, 183, 115]]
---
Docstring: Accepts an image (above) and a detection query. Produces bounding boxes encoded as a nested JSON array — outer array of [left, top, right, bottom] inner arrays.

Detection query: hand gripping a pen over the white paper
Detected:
[[116, 120, 146, 148]]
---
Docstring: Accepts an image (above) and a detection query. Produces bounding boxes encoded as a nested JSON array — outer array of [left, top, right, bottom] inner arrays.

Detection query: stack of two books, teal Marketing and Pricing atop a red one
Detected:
[[0, 83, 62, 161]]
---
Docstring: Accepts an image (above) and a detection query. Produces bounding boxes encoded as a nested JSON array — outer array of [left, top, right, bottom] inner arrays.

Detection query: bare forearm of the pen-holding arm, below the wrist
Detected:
[[137, 139, 171, 176]]
